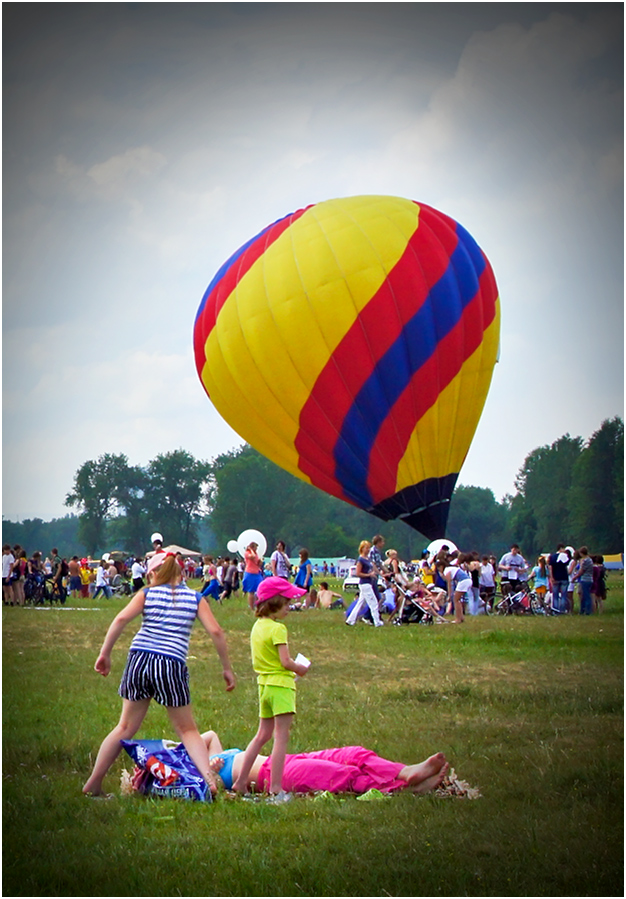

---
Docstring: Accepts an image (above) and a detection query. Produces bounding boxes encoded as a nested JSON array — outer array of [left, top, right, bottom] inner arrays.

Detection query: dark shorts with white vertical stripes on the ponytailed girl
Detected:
[[118, 649, 191, 708]]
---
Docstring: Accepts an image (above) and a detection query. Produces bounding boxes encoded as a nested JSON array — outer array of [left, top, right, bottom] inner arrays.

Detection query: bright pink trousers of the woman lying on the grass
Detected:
[[257, 746, 406, 793]]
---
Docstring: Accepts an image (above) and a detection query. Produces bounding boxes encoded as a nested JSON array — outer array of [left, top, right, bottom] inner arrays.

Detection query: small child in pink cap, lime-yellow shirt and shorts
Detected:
[[233, 576, 308, 802]]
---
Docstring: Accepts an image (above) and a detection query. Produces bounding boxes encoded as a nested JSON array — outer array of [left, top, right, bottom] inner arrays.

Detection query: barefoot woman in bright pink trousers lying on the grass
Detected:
[[197, 730, 449, 793]]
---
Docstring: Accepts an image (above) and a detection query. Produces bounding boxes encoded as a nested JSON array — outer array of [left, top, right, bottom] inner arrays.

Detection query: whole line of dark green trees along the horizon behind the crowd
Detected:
[[3, 418, 624, 559]]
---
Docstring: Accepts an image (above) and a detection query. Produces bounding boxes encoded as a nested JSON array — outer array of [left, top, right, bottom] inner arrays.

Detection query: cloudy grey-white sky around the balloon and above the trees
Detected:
[[2, 3, 624, 527]]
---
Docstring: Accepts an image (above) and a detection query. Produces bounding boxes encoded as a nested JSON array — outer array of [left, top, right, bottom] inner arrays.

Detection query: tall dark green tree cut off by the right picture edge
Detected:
[[569, 418, 624, 553]]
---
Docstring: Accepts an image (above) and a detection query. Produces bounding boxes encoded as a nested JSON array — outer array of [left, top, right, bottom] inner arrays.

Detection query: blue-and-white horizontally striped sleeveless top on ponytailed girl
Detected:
[[130, 584, 200, 662]]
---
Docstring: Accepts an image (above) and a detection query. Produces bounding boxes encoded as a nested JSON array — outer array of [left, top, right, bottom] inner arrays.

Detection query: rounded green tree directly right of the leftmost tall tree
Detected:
[[144, 449, 211, 549]]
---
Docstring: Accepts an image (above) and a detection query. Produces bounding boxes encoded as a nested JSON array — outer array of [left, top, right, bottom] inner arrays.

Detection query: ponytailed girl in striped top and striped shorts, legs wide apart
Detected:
[[83, 553, 235, 798]]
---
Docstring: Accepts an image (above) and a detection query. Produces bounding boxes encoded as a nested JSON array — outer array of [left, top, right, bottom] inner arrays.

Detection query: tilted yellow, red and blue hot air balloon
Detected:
[[194, 196, 500, 539]]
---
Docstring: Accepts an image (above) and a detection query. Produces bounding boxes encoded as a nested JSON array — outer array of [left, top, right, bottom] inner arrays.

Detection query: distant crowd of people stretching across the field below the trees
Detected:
[[2, 534, 606, 627]]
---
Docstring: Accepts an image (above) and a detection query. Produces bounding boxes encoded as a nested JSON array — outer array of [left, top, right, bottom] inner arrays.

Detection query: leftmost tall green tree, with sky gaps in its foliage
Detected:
[[65, 453, 128, 555]]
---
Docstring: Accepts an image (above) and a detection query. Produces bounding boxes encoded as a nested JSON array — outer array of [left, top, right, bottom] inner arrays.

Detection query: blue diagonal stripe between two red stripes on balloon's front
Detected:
[[334, 224, 485, 508]]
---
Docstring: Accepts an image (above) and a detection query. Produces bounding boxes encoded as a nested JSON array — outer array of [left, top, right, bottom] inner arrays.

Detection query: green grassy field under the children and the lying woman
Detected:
[[3, 577, 624, 896]]
